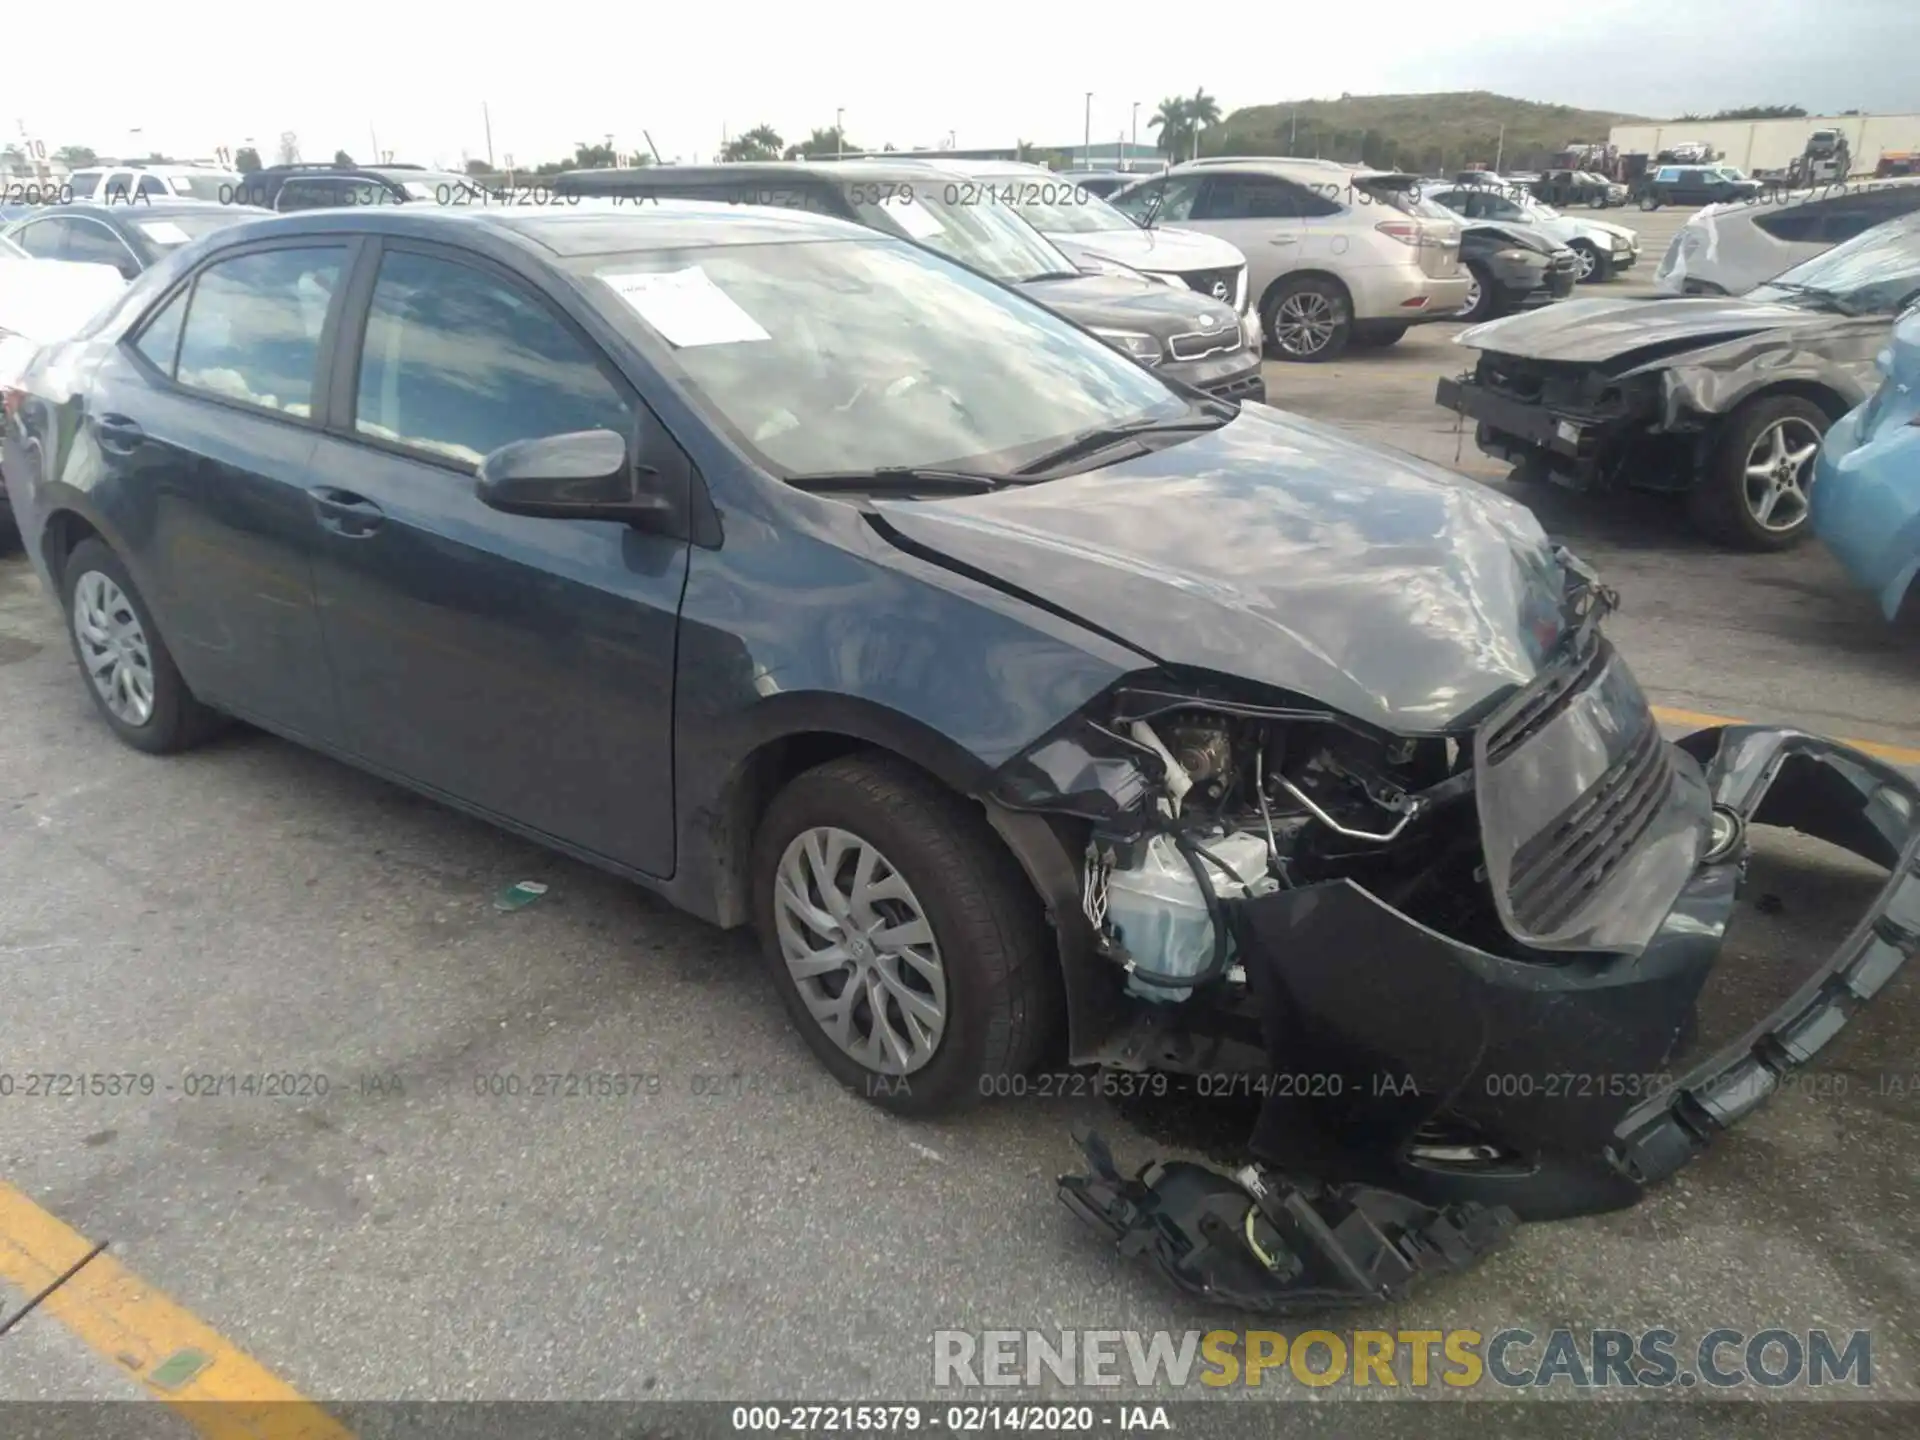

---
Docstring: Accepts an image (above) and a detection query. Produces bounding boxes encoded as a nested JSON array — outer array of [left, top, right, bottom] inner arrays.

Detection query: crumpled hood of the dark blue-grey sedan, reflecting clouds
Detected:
[[876, 405, 1565, 735]]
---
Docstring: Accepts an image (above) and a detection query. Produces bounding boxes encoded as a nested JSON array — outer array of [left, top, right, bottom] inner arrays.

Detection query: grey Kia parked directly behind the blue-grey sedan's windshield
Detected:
[[553, 159, 1267, 399]]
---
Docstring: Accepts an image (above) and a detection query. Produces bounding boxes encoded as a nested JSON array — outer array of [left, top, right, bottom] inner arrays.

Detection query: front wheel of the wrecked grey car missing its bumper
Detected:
[[1688, 396, 1832, 551]]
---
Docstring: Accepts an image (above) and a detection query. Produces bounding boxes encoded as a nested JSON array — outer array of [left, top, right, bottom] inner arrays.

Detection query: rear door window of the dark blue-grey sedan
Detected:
[[177, 246, 348, 417]]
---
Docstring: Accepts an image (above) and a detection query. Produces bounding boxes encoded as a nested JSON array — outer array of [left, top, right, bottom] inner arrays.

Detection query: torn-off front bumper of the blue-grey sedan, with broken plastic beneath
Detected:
[[1062, 726, 1920, 1313]]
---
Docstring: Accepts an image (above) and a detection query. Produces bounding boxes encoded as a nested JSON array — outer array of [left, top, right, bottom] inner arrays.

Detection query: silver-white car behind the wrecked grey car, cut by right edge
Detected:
[[1653, 177, 1920, 296]]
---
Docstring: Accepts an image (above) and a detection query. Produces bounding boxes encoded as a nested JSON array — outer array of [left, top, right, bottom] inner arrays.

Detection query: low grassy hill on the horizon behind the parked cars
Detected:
[[1200, 90, 1642, 173]]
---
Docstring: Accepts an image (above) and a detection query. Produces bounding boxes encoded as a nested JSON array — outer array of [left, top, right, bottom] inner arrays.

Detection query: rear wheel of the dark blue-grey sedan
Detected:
[[60, 540, 225, 755]]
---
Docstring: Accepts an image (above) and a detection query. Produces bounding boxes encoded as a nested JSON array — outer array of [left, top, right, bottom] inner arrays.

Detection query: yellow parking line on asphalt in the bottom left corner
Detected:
[[0, 1181, 353, 1440]]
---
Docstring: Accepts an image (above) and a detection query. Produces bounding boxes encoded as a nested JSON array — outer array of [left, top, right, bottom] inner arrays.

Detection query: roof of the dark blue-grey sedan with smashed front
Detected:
[[183, 200, 887, 259]]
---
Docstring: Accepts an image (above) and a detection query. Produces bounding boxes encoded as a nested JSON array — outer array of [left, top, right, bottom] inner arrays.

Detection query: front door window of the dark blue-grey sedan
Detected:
[[353, 252, 634, 465]]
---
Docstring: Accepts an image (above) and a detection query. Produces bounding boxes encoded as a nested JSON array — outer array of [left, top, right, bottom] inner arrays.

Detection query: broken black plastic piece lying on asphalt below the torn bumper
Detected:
[[1060, 1127, 1519, 1315]]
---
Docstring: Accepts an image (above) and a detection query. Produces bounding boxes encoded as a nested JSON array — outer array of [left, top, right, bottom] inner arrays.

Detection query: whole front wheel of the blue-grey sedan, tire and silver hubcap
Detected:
[[753, 755, 1060, 1116]]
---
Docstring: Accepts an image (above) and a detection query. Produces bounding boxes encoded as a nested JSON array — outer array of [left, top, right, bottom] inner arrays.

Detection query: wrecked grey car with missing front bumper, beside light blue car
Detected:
[[1434, 215, 1920, 549]]
